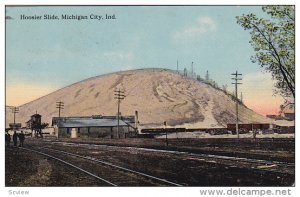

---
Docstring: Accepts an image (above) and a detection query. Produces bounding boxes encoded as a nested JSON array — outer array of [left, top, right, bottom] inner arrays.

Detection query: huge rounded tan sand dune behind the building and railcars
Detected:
[[6, 69, 270, 128]]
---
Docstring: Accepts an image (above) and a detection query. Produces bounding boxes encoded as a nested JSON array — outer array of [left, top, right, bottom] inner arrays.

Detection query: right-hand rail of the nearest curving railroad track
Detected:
[[43, 147, 182, 186]]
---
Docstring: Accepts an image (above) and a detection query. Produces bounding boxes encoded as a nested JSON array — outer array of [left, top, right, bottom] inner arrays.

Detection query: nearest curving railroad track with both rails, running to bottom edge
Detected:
[[20, 147, 182, 186]]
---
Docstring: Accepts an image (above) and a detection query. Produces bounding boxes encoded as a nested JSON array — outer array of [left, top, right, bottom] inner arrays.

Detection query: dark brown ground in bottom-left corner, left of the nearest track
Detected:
[[5, 148, 116, 187]]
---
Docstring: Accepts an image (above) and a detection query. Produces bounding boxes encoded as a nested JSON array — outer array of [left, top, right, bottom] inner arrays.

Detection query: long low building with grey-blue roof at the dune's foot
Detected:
[[52, 116, 136, 138]]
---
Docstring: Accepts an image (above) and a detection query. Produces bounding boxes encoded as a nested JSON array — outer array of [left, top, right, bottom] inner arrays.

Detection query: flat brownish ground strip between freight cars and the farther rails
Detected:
[[60, 138, 295, 163]]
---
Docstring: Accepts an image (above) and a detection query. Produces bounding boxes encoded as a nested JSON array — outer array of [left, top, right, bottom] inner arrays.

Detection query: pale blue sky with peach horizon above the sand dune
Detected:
[[6, 6, 282, 115]]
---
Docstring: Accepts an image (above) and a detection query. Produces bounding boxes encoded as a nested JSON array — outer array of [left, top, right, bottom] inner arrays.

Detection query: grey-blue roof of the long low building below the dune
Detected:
[[57, 117, 127, 128]]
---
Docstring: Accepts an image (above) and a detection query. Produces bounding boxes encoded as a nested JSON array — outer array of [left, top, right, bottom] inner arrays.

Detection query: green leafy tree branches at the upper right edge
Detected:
[[236, 6, 295, 98]]
